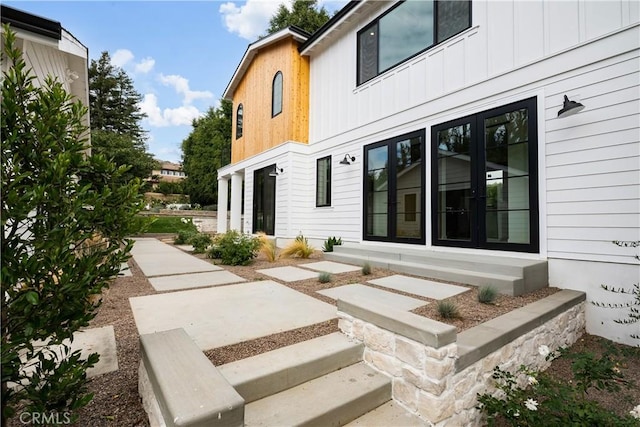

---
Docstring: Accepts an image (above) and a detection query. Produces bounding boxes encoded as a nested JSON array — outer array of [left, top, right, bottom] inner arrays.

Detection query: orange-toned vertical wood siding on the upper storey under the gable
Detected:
[[231, 38, 309, 164]]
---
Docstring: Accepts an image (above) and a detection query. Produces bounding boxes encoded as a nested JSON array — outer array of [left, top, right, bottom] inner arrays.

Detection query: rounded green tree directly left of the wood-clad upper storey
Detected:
[[182, 99, 232, 205]]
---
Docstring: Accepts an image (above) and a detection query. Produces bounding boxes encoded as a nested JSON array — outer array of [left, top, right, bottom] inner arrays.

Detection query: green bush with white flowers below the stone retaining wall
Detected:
[[477, 346, 640, 427]]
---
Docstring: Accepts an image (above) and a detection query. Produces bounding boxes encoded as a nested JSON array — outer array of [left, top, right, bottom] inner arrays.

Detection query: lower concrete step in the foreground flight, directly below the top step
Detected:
[[244, 362, 391, 427]]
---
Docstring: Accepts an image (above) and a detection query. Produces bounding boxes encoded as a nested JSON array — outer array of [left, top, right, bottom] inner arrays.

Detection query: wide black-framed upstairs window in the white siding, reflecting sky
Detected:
[[358, 0, 471, 84]]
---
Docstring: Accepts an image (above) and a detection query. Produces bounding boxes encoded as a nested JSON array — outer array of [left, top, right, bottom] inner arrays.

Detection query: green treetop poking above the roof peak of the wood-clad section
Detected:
[[267, 0, 329, 34]]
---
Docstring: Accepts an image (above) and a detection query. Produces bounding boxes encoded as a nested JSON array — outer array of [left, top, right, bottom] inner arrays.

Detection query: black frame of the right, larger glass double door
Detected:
[[431, 97, 540, 253]]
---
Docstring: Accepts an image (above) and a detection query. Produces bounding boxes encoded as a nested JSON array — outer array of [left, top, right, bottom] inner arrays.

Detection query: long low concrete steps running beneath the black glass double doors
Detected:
[[324, 244, 549, 295]]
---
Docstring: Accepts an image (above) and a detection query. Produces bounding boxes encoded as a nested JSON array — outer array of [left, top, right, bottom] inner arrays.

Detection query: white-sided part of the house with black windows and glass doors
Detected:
[[218, 0, 640, 342]]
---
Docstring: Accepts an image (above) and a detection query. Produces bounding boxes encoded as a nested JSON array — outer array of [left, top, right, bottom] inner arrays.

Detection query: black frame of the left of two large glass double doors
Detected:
[[362, 129, 427, 245]]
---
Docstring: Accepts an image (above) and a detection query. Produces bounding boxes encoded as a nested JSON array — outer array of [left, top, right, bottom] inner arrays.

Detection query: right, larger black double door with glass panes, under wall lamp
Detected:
[[432, 98, 539, 252]]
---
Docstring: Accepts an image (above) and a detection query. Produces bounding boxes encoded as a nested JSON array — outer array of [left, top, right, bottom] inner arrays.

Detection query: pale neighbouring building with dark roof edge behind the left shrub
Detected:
[[0, 5, 90, 143]]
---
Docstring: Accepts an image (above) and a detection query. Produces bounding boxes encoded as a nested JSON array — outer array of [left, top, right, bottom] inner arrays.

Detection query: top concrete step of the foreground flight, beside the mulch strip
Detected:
[[217, 332, 363, 403]]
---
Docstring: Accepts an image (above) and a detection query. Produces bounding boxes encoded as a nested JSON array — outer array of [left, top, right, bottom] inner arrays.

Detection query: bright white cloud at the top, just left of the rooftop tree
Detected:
[[218, 0, 282, 41]]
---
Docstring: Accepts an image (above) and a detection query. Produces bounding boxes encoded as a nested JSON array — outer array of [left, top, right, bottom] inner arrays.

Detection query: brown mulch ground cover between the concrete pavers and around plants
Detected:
[[9, 239, 640, 427]]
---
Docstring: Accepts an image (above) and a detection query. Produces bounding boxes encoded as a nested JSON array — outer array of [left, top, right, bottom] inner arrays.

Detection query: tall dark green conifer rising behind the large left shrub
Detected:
[[89, 52, 157, 180]]
